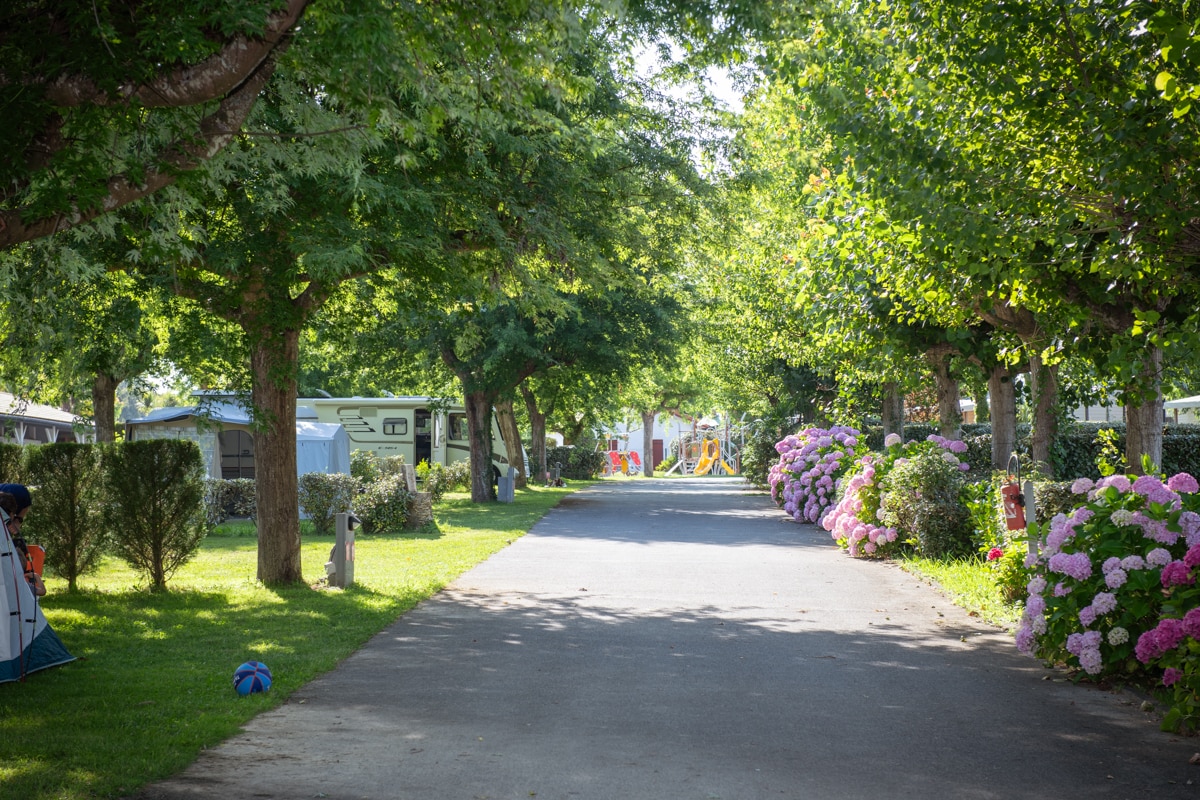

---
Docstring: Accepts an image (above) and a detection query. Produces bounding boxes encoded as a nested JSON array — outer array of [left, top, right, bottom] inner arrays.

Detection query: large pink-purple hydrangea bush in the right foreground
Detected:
[[1016, 473, 1200, 700]]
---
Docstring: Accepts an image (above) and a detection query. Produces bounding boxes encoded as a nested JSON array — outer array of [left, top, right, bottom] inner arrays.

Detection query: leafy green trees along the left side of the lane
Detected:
[[0, 0, 752, 584]]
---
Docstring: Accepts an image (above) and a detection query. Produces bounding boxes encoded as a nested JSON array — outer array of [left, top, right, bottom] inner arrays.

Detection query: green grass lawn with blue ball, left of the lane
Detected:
[[0, 482, 584, 800]]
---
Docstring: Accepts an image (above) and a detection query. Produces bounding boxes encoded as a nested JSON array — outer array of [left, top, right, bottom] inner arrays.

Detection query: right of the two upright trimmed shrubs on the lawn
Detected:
[[101, 439, 206, 591]]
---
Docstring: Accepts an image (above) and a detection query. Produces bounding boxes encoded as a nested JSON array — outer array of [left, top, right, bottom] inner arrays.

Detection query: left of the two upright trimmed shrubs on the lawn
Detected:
[[22, 443, 109, 591]]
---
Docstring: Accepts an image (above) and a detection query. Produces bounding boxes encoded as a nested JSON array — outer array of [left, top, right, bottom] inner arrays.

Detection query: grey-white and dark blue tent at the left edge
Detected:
[[0, 524, 74, 684]]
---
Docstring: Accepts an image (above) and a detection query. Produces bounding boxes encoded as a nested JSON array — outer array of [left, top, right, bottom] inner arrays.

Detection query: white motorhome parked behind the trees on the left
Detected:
[[296, 397, 509, 474]]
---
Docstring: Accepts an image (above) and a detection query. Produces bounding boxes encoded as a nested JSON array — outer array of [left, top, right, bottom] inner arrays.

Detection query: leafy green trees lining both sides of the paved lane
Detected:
[[9, 0, 1200, 583]]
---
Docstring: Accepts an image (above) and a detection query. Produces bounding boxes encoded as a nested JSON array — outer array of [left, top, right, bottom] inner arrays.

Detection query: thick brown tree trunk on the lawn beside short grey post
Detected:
[[250, 329, 304, 585]]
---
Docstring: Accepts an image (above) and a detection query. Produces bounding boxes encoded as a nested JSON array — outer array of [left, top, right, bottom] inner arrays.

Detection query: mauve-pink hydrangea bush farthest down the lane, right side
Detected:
[[767, 426, 859, 523]]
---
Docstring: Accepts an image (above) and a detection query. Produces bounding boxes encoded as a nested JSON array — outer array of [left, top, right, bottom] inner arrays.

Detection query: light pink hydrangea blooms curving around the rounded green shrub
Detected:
[[821, 433, 970, 558]]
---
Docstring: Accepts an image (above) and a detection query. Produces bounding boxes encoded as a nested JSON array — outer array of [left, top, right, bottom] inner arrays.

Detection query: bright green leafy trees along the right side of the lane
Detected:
[[709, 0, 1200, 469]]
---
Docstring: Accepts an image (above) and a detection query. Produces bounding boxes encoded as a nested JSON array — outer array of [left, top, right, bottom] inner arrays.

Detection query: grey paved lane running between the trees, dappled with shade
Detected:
[[136, 479, 1200, 800]]
